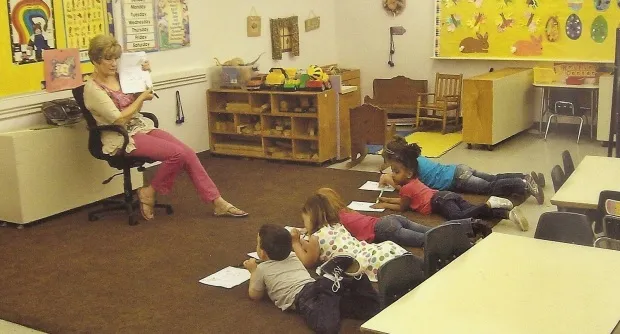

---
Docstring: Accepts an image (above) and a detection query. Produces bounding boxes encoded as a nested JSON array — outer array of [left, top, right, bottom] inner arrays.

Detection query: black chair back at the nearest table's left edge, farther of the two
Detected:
[[424, 223, 473, 278]]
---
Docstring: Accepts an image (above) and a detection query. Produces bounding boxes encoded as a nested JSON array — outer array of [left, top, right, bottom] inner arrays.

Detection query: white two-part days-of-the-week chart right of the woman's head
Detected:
[[122, 0, 190, 51]]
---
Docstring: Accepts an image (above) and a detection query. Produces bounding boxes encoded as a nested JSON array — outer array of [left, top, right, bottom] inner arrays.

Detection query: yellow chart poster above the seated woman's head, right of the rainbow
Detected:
[[63, 0, 114, 62]]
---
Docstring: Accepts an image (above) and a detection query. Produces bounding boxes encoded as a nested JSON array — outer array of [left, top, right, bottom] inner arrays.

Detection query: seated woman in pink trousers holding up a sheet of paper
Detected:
[[84, 35, 248, 220]]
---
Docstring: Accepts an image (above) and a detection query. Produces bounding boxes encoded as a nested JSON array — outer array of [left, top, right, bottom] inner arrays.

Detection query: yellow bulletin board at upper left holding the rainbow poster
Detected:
[[0, 0, 114, 97]]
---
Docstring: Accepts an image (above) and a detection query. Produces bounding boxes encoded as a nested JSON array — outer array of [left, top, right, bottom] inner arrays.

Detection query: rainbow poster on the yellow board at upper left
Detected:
[[7, 0, 56, 65]]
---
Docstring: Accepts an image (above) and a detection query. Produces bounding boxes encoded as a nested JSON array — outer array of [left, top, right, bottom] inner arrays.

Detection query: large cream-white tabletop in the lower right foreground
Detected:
[[361, 233, 620, 334]]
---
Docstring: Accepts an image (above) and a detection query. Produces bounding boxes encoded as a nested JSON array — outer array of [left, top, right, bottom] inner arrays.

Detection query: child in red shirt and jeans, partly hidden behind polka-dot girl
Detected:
[[317, 188, 431, 247]]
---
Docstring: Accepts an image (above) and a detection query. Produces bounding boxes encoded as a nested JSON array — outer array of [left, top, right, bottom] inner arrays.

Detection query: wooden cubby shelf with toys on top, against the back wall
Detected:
[[207, 89, 337, 163]]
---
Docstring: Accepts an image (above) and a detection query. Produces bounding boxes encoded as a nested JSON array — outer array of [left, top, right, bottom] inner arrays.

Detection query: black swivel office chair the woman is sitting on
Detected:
[[73, 86, 173, 225]]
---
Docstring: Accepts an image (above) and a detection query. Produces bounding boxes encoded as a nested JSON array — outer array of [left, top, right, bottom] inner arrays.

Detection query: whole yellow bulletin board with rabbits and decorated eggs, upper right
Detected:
[[434, 0, 620, 63]]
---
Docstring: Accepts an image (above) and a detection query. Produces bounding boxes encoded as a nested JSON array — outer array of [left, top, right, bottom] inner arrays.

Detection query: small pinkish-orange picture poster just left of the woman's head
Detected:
[[43, 49, 83, 93]]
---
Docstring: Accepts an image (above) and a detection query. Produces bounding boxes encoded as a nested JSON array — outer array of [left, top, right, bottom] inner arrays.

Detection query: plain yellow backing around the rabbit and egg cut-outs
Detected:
[[435, 0, 620, 62]]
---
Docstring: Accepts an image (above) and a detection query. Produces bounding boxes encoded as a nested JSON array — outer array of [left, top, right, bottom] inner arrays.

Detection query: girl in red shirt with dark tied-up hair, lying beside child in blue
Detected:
[[372, 144, 529, 231]]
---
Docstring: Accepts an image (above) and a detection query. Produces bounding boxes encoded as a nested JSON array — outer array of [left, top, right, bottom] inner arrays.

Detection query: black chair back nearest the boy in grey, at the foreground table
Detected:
[[377, 253, 424, 309]]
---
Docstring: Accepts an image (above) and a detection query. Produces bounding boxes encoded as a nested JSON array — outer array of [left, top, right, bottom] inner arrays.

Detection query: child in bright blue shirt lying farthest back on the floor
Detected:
[[379, 136, 545, 204]]
